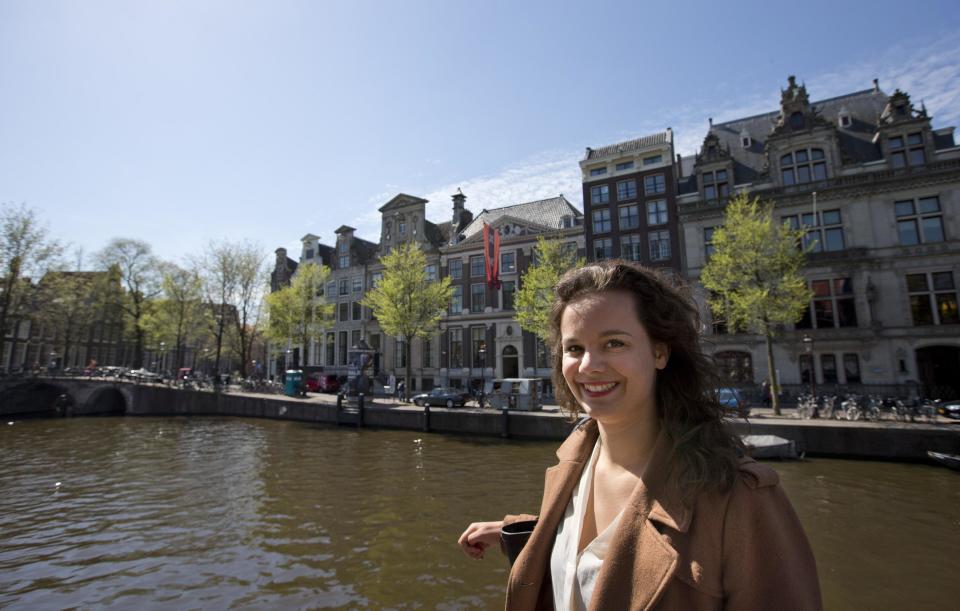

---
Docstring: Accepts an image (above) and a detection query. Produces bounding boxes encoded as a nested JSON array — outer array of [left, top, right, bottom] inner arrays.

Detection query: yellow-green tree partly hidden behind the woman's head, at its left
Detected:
[[514, 236, 584, 342]]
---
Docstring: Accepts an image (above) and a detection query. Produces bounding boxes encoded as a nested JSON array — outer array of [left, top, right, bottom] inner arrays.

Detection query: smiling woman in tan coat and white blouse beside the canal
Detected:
[[459, 261, 821, 610]]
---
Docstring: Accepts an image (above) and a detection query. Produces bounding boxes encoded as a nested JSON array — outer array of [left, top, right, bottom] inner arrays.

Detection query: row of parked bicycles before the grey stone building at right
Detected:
[[797, 394, 940, 422]]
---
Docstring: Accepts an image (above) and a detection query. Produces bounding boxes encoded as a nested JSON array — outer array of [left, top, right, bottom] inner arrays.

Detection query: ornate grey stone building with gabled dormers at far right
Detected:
[[677, 77, 960, 397]]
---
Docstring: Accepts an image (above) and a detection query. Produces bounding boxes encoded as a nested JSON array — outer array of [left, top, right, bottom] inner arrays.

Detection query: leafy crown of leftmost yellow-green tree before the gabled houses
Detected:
[[266, 263, 334, 366]]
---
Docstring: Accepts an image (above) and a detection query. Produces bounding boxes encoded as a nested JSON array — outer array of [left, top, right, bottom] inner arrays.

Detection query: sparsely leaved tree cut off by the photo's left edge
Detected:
[[0, 204, 61, 369]]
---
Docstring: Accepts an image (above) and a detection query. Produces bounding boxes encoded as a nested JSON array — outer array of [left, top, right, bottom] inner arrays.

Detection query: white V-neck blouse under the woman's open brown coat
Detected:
[[550, 439, 623, 611]]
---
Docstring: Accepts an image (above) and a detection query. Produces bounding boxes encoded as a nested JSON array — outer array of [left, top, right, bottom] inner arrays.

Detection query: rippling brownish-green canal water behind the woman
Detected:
[[0, 418, 960, 609]]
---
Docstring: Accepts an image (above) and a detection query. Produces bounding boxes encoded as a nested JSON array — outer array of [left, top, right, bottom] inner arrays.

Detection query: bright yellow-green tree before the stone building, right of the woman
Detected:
[[700, 193, 812, 415]]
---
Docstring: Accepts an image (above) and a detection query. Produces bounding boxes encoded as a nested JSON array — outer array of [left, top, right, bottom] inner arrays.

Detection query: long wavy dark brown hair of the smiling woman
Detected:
[[550, 259, 744, 502]]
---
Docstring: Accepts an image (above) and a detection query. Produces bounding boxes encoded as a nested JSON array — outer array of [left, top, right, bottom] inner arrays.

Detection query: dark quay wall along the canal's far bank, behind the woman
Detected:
[[118, 386, 960, 461]]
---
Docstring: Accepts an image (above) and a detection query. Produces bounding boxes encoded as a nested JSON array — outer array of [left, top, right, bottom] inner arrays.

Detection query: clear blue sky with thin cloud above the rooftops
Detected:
[[0, 0, 960, 261]]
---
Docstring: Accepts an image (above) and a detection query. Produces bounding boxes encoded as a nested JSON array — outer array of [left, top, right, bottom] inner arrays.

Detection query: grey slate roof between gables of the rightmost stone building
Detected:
[[679, 88, 889, 193]]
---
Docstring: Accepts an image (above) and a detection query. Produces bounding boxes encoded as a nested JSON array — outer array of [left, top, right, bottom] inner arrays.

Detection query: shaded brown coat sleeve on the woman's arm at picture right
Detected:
[[723, 463, 822, 611]]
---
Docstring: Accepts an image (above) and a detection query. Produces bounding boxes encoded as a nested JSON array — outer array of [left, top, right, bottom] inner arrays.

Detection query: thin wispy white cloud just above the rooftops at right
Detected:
[[355, 35, 960, 239]]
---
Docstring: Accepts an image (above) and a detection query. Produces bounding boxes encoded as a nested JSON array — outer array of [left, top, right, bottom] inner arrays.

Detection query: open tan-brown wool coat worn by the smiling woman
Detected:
[[505, 420, 821, 611]]
